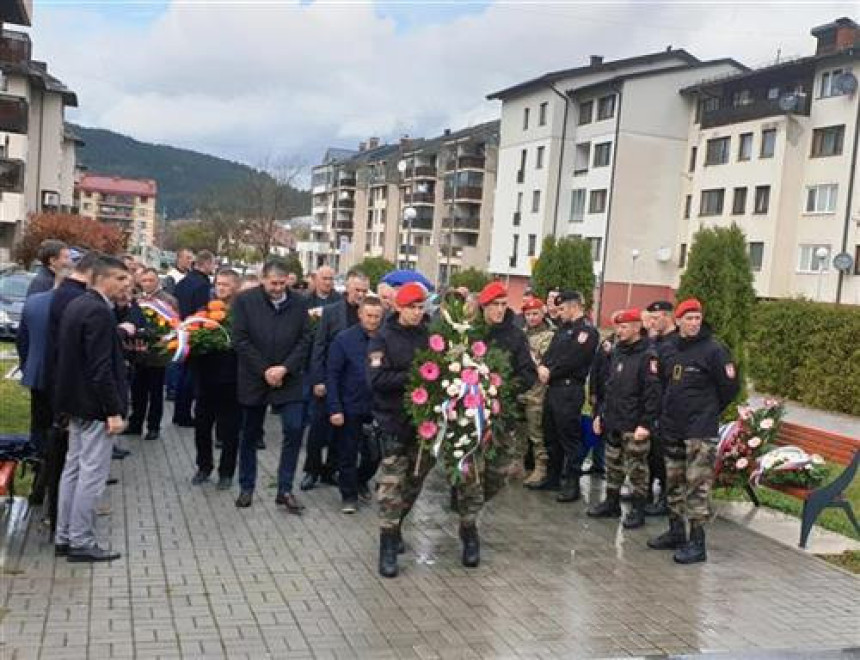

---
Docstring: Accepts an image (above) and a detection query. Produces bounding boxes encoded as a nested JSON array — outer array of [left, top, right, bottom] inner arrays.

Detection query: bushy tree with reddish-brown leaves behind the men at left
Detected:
[[15, 213, 126, 266]]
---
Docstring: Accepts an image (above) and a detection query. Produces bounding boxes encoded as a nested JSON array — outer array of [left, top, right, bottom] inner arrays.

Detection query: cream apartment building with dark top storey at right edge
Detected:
[[677, 18, 860, 304]]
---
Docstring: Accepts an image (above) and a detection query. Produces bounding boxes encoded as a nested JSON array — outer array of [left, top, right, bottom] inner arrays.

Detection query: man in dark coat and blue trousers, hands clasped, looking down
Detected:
[[232, 259, 310, 514]]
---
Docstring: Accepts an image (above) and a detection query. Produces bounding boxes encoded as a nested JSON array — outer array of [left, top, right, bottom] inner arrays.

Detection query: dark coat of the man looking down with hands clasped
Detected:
[[230, 280, 310, 406]]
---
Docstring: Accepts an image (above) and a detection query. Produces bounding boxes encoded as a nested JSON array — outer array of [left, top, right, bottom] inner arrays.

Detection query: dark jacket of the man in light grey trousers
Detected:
[[54, 290, 128, 420]]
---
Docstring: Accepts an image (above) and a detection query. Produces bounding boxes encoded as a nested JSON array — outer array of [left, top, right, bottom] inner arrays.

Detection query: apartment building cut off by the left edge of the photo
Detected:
[[0, 7, 79, 261]]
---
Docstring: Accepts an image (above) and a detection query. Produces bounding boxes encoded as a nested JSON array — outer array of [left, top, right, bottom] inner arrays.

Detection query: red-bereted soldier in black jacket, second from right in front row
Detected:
[[587, 309, 662, 529]]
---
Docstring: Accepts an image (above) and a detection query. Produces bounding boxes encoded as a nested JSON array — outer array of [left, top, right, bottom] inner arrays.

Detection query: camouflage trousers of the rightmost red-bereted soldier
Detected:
[[665, 438, 717, 523]]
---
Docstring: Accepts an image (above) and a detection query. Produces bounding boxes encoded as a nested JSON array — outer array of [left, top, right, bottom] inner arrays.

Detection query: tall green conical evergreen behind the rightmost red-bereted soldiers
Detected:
[[677, 224, 756, 401]]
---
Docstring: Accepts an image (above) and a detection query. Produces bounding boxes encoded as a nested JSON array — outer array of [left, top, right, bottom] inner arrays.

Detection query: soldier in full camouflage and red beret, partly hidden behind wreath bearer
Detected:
[[520, 296, 554, 486]]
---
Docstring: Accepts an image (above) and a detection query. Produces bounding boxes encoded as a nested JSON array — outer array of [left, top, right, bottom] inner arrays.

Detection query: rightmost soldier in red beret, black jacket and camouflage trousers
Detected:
[[648, 298, 740, 564]]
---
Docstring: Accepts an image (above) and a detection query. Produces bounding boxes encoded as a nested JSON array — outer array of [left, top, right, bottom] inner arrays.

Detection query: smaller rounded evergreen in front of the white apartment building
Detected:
[[532, 236, 594, 309]]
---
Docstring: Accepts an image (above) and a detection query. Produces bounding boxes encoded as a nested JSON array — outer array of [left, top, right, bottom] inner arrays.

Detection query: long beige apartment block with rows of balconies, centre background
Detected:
[[312, 122, 499, 283]]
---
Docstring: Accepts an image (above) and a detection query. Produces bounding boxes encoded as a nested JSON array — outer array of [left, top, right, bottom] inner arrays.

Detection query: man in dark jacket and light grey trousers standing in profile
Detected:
[[55, 257, 130, 562]]
